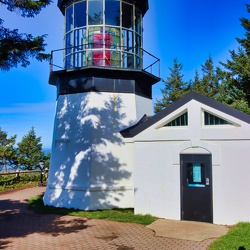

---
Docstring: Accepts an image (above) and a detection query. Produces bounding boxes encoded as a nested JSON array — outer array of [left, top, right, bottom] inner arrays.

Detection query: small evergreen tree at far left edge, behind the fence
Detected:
[[0, 128, 17, 171]]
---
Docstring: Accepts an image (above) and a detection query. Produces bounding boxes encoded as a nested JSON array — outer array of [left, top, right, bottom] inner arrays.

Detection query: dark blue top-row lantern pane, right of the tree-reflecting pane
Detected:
[[105, 0, 120, 26]]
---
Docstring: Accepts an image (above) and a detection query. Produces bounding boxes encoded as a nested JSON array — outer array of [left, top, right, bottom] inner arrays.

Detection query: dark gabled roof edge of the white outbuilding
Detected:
[[120, 92, 250, 138]]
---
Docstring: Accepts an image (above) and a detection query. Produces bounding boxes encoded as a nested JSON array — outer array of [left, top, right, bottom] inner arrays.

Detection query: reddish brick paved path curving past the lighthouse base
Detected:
[[0, 187, 215, 250]]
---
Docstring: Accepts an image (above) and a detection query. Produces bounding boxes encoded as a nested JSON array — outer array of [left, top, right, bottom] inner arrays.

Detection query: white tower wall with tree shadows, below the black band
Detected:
[[44, 92, 153, 210]]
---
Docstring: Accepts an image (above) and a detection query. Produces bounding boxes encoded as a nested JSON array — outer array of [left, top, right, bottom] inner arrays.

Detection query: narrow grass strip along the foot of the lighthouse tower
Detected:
[[29, 195, 158, 225]]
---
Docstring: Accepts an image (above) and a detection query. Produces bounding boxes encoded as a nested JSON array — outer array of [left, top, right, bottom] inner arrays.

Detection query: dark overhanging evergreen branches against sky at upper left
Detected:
[[0, 0, 51, 71]]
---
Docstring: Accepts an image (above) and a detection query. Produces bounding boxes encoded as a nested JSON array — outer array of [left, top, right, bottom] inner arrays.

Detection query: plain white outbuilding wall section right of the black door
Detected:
[[213, 140, 250, 224]]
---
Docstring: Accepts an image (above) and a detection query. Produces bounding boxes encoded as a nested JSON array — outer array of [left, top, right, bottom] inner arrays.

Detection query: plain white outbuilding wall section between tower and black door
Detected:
[[134, 142, 180, 220]]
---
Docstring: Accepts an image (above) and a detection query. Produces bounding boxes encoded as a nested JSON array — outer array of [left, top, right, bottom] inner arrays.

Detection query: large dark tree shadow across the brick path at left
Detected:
[[0, 200, 90, 241]]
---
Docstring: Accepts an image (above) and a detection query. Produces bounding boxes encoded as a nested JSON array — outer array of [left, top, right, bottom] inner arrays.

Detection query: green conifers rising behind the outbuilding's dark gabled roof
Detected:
[[154, 4, 250, 114]]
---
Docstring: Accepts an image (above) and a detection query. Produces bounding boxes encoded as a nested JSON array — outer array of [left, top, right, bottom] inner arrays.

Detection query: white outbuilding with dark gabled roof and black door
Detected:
[[121, 92, 250, 224]]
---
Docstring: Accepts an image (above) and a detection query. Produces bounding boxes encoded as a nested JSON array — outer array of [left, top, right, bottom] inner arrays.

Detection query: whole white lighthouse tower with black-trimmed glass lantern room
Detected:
[[44, 0, 160, 210]]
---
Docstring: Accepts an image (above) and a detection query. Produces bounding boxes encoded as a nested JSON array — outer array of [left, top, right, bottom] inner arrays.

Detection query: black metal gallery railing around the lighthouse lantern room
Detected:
[[50, 43, 160, 77]]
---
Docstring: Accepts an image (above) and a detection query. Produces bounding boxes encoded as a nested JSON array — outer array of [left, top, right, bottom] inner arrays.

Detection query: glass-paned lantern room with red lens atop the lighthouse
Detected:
[[58, 0, 148, 70]]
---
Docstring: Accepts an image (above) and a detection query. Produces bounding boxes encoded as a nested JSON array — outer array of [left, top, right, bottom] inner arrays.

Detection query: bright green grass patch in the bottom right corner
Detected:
[[209, 222, 250, 250]]
